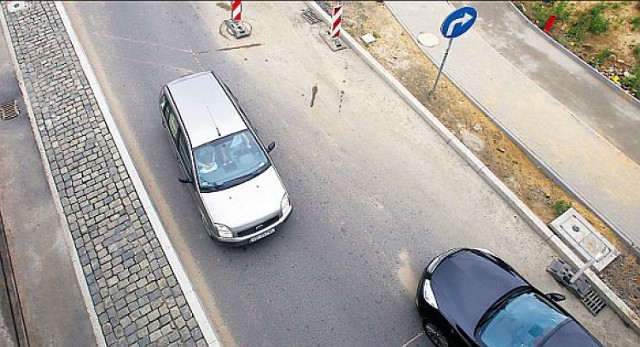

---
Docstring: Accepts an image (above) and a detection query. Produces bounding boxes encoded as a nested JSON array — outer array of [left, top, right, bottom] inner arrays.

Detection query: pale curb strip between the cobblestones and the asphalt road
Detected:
[[55, 1, 221, 346]]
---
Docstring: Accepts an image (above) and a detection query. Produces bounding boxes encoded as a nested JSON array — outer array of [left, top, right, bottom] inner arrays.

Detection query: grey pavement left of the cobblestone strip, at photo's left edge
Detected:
[[0, 19, 96, 346]]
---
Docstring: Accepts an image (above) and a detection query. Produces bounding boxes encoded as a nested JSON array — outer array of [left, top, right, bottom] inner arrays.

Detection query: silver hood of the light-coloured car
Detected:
[[200, 166, 286, 231]]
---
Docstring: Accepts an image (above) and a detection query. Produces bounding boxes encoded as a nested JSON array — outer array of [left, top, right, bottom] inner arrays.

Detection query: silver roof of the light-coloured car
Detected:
[[167, 71, 247, 148]]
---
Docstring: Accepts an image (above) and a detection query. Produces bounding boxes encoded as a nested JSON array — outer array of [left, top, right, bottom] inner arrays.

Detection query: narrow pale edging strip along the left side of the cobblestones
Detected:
[[0, 4, 107, 347]]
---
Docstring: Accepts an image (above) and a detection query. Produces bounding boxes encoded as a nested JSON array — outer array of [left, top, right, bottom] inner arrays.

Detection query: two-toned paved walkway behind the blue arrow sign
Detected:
[[385, 1, 640, 254]]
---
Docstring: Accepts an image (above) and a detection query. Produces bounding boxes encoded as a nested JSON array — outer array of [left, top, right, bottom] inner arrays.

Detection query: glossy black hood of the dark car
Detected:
[[431, 249, 530, 336]]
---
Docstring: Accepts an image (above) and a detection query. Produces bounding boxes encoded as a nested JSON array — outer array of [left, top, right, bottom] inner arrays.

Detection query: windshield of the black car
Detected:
[[478, 292, 568, 347]]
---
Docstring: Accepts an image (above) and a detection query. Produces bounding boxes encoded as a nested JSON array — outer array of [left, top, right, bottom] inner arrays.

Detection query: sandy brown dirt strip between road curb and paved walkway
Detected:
[[318, 1, 640, 314]]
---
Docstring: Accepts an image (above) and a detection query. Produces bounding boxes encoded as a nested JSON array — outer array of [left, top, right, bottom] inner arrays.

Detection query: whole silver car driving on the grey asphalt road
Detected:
[[160, 71, 292, 245]]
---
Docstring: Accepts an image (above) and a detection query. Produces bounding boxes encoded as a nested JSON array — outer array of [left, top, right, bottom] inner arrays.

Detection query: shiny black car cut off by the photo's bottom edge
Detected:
[[416, 248, 602, 347]]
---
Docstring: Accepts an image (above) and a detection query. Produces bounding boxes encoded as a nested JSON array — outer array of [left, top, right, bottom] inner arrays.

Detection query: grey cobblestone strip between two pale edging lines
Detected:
[[2, 2, 206, 346]]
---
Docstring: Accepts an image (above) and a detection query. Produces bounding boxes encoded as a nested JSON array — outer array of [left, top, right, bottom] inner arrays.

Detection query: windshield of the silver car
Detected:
[[193, 130, 271, 193]]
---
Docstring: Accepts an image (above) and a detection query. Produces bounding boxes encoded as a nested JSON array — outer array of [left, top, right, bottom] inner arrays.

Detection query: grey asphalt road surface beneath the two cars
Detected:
[[60, 2, 604, 346]]
